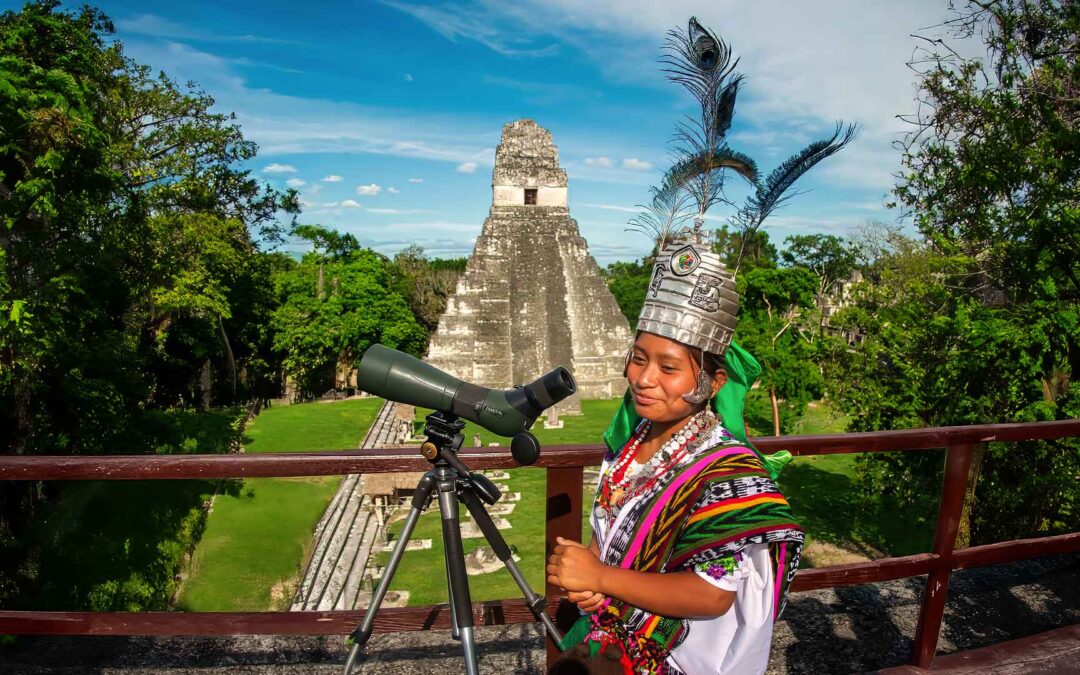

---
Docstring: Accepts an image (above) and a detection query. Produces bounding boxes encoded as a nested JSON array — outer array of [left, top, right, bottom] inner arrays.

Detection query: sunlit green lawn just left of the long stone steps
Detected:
[[178, 399, 382, 611]]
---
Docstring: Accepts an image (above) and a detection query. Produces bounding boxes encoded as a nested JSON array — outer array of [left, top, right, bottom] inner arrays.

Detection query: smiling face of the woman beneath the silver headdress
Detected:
[[626, 333, 715, 422]]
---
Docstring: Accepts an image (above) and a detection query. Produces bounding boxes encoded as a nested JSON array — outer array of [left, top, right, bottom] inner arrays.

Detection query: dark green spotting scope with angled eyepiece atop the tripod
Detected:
[[356, 345, 577, 436]]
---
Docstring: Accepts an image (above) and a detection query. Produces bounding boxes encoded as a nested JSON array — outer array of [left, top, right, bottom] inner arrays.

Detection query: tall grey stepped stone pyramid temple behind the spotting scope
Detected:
[[427, 120, 632, 414]]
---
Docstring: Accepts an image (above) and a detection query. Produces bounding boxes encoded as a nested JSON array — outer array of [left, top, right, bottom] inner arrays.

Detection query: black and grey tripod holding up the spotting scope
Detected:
[[345, 411, 562, 675]]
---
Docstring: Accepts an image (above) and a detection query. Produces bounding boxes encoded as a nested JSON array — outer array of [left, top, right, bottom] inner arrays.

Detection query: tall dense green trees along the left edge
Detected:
[[0, 0, 296, 607]]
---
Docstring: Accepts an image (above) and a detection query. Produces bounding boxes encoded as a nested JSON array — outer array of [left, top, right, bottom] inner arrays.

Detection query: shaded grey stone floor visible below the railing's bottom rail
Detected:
[[0, 555, 1080, 675]]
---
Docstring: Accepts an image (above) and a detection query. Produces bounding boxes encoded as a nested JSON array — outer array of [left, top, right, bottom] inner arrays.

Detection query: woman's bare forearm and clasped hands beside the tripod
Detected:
[[548, 538, 735, 619]]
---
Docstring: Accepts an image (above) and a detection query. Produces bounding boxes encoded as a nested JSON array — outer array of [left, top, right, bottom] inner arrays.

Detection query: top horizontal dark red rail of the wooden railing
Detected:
[[0, 420, 1080, 481]]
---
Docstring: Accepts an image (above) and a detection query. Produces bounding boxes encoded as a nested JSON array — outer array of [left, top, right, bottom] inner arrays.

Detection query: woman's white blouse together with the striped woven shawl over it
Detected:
[[583, 424, 804, 675]]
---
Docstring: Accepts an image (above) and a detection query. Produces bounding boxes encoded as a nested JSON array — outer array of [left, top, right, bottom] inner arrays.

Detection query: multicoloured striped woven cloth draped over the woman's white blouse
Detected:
[[563, 427, 804, 674]]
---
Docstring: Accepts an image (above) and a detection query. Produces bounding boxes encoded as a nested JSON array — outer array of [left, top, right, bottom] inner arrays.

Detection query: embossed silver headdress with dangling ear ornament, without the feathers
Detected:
[[637, 228, 739, 404]]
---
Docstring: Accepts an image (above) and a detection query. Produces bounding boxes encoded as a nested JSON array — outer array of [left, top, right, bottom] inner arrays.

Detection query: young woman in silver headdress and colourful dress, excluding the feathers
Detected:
[[548, 244, 802, 675]]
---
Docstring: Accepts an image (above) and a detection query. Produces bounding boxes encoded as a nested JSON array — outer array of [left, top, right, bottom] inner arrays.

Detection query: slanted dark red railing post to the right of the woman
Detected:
[[912, 443, 972, 667]]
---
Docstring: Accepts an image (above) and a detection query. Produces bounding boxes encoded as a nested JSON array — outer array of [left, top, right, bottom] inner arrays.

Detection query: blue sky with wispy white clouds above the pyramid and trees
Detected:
[[29, 0, 976, 265]]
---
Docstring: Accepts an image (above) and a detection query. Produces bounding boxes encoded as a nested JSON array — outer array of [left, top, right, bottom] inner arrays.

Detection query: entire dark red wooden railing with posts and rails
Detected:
[[0, 420, 1080, 667]]
